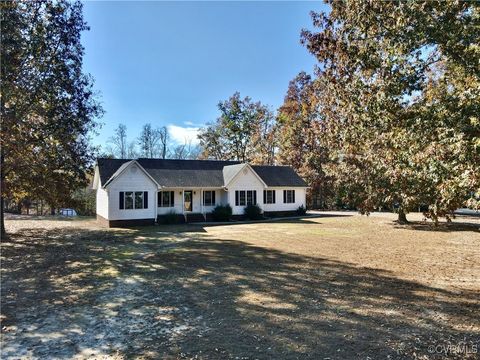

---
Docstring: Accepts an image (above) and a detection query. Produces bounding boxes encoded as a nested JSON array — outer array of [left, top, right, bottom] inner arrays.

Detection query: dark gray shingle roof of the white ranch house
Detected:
[[97, 158, 307, 187]]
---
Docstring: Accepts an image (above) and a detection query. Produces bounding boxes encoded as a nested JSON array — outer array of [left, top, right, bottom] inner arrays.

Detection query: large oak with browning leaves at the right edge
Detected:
[[302, 1, 480, 221]]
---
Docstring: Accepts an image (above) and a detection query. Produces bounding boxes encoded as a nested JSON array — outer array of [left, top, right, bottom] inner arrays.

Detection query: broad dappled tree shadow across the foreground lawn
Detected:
[[1, 227, 480, 359]]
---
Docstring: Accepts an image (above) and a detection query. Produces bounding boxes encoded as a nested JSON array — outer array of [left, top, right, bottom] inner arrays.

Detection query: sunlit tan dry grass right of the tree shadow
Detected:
[[201, 212, 480, 291]]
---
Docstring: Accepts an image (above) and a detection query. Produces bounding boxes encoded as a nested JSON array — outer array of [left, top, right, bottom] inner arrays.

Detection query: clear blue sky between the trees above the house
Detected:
[[82, 1, 325, 145]]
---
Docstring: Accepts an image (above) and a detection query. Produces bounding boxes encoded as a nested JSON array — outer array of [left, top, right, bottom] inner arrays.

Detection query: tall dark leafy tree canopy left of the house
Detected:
[[0, 1, 102, 232]]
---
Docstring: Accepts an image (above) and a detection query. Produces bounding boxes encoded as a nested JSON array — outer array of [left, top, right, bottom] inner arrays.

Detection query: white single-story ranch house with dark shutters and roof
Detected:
[[93, 158, 307, 226]]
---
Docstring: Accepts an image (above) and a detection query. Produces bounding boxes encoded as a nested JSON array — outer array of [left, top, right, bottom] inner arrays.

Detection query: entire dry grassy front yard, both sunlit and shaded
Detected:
[[1, 213, 480, 359]]
